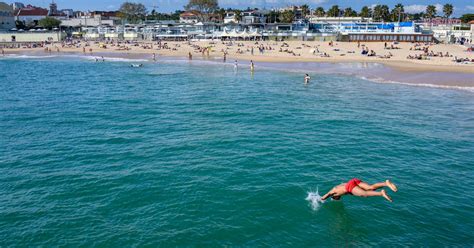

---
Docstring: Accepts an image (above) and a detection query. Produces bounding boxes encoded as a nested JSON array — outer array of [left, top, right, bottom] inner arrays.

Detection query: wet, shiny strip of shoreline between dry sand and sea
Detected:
[[6, 49, 474, 92]]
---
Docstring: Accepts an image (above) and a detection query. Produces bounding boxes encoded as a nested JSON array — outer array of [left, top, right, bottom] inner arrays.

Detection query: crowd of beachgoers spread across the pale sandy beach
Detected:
[[1, 40, 474, 70]]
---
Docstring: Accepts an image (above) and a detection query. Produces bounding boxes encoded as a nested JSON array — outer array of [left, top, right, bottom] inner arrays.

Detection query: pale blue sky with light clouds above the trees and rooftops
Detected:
[[4, 0, 474, 17]]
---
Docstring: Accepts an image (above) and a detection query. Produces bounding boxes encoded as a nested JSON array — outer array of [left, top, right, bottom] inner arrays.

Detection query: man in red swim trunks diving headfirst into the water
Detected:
[[321, 178, 398, 202]]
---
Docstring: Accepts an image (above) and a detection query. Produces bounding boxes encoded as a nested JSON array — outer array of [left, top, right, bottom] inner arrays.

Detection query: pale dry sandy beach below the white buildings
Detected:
[[5, 41, 474, 73]]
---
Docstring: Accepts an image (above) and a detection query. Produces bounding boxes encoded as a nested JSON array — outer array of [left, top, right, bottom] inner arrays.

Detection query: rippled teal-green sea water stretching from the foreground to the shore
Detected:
[[0, 57, 474, 247]]
